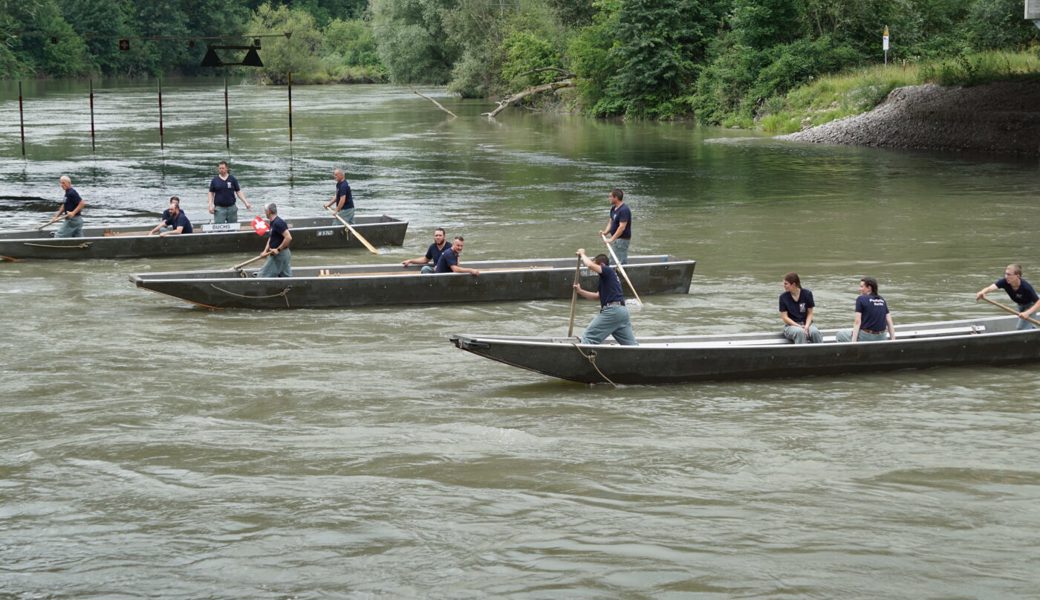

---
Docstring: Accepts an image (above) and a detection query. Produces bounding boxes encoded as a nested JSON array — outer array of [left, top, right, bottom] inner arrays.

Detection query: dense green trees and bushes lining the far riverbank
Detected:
[[0, 0, 1040, 125]]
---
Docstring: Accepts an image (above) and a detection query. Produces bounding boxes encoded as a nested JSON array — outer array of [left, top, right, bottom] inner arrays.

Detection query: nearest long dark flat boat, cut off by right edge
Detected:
[[450, 316, 1040, 384]]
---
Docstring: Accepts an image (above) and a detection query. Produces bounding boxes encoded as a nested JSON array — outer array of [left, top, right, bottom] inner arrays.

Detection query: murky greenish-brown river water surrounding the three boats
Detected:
[[0, 79, 1040, 599]]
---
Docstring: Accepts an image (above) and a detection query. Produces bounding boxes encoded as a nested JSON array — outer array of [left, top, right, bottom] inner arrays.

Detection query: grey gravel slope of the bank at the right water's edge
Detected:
[[778, 79, 1040, 156]]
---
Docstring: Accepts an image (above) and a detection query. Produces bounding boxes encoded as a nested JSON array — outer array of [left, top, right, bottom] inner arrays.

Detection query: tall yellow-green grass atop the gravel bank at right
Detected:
[[758, 52, 1040, 134]]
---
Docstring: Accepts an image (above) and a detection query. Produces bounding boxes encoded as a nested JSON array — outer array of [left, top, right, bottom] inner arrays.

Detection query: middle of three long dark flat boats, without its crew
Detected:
[[130, 255, 697, 309]]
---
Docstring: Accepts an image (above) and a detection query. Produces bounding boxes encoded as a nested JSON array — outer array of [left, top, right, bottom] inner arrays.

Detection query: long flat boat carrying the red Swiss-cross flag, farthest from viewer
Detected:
[[0, 215, 408, 259]]
